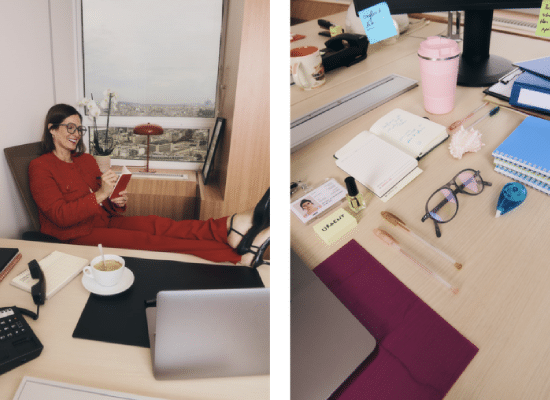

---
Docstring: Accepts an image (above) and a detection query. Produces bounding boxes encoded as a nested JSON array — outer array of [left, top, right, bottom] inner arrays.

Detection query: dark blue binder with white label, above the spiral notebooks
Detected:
[[510, 71, 550, 113]]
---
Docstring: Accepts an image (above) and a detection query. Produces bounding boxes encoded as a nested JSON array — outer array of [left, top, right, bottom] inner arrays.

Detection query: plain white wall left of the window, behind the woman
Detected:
[[0, 0, 77, 238]]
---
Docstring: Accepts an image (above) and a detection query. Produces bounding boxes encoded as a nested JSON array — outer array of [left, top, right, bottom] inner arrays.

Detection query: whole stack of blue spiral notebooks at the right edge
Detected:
[[492, 116, 550, 194]]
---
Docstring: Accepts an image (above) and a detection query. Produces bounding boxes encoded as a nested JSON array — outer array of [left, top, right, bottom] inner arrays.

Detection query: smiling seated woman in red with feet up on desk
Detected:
[[29, 104, 270, 267]]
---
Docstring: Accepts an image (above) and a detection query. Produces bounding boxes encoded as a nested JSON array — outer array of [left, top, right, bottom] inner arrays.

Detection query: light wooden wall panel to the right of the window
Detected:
[[200, 0, 270, 219]]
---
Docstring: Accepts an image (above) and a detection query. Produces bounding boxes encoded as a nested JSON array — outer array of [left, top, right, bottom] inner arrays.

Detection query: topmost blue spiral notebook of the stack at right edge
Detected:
[[492, 116, 550, 177]]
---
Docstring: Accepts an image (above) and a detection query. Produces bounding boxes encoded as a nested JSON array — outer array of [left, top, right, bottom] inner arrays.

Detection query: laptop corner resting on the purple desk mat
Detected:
[[290, 252, 376, 400]]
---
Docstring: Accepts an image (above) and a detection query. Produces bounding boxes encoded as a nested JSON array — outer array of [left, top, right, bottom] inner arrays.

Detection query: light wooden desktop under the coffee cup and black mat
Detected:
[[0, 239, 269, 400]]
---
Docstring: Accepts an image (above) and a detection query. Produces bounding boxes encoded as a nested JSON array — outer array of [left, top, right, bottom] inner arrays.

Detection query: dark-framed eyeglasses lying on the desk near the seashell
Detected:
[[422, 168, 492, 237]]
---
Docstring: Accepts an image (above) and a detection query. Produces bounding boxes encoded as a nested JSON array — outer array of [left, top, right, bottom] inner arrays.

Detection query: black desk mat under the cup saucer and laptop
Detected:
[[73, 257, 264, 347]]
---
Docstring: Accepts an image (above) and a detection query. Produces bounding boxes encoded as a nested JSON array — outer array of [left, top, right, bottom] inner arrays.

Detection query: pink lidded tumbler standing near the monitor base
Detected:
[[418, 36, 460, 114]]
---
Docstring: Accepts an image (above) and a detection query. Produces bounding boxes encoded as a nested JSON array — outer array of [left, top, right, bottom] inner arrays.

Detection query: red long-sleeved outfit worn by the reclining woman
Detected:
[[29, 153, 241, 263]]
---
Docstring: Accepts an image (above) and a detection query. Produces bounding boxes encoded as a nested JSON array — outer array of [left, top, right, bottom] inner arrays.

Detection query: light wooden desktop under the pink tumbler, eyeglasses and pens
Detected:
[[291, 13, 550, 399]]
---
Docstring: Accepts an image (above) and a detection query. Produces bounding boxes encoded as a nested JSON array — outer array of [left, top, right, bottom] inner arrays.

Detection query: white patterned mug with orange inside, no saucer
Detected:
[[290, 46, 325, 90]]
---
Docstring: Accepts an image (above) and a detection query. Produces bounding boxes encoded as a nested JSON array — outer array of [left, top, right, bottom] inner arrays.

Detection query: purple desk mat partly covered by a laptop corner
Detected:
[[314, 240, 478, 400]]
